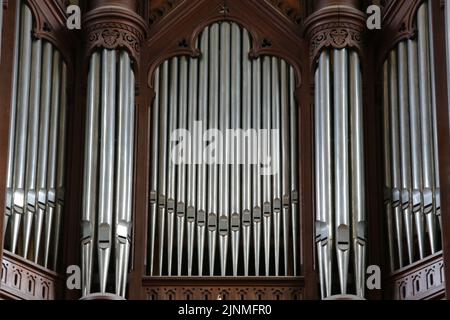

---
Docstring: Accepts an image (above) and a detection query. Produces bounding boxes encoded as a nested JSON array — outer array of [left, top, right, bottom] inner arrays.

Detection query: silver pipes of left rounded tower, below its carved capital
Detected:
[[81, 49, 135, 297]]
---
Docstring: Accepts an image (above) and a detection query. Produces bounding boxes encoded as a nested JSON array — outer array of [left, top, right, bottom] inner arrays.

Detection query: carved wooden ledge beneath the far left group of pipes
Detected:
[[0, 251, 60, 300]]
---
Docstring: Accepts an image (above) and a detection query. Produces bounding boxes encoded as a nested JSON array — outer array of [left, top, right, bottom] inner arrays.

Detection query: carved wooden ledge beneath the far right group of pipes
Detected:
[[390, 252, 445, 300]]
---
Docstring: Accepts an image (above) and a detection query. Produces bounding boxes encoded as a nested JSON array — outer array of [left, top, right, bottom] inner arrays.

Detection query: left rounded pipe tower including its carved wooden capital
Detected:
[[81, 0, 146, 299]]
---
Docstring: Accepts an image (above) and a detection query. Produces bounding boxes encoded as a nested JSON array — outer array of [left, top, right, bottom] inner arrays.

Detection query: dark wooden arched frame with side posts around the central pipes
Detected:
[[129, 0, 317, 299]]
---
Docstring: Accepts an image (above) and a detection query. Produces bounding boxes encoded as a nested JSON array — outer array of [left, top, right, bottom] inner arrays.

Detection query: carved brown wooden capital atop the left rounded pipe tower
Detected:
[[84, 7, 147, 62]]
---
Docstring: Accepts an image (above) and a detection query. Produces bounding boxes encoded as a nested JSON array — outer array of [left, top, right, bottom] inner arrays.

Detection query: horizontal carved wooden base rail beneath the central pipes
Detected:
[[143, 278, 304, 301]]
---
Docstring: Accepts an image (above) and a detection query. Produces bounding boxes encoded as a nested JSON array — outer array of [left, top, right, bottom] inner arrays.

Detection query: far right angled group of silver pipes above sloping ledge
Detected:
[[383, 1, 442, 270]]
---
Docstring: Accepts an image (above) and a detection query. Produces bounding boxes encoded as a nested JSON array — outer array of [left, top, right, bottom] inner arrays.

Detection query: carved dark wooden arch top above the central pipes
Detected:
[[143, 0, 306, 92]]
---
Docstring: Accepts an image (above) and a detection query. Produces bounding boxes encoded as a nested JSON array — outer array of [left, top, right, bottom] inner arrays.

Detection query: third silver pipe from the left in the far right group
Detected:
[[397, 41, 414, 264]]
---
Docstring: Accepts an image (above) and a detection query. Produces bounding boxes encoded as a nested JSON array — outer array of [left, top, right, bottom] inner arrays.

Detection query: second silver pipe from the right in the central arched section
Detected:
[[280, 60, 290, 276]]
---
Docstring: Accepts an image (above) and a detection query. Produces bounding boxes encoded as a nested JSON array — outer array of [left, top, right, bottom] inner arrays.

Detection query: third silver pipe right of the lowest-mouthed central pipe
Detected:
[[251, 60, 262, 276]]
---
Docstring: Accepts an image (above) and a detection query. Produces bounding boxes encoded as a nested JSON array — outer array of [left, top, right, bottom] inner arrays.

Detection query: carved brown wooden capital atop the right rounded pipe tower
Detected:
[[305, 6, 366, 63]]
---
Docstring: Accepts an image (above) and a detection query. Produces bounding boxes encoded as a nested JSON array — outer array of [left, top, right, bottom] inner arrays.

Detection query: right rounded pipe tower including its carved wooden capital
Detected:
[[305, 0, 367, 298]]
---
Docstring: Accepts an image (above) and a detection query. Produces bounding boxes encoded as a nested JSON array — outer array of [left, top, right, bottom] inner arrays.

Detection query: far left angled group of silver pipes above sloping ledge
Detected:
[[3, 4, 68, 270]]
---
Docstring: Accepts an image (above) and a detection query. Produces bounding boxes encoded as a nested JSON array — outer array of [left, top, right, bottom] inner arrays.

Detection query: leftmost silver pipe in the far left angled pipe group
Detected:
[[3, 0, 22, 238]]
